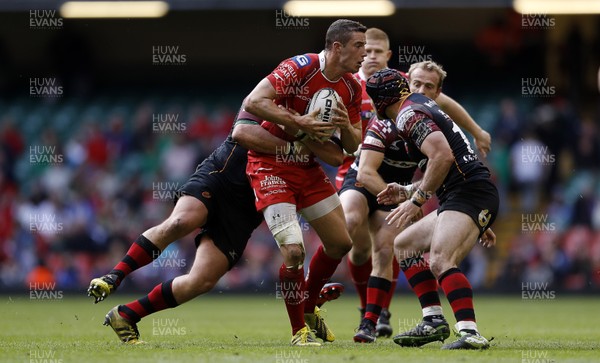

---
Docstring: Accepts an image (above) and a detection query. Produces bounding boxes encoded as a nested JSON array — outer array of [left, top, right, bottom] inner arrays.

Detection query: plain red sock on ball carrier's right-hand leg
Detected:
[[304, 246, 342, 314]]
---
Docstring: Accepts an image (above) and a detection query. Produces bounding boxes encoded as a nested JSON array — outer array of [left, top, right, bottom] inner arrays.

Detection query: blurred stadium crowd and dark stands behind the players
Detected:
[[0, 5, 600, 293]]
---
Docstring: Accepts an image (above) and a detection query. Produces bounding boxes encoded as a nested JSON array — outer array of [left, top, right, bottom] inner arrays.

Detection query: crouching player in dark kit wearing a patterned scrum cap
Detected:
[[367, 69, 499, 349]]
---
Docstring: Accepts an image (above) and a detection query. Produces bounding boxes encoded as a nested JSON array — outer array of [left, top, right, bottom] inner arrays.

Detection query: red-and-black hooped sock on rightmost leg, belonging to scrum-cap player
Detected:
[[439, 267, 475, 322]]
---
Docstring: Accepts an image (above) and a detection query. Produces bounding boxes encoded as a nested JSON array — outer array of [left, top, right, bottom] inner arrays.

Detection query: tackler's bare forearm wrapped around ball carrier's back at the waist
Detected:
[[231, 124, 290, 155]]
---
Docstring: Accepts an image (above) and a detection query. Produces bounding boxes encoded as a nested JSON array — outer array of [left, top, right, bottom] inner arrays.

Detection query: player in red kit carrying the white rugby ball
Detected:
[[244, 19, 366, 345]]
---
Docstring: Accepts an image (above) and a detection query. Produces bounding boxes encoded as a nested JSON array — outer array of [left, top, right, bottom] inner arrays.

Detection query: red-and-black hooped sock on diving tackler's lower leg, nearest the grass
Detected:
[[119, 280, 179, 323]]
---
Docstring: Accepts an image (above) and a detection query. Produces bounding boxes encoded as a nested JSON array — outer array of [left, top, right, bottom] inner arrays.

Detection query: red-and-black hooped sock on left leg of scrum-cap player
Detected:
[[401, 257, 441, 308]]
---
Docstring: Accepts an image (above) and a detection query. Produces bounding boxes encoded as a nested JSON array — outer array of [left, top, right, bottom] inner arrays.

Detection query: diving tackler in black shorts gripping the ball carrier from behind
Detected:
[[88, 106, 342, 344]]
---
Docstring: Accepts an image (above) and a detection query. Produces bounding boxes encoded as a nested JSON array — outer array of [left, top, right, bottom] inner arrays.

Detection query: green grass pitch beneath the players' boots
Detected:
[[0, 293, 600, 363]]
